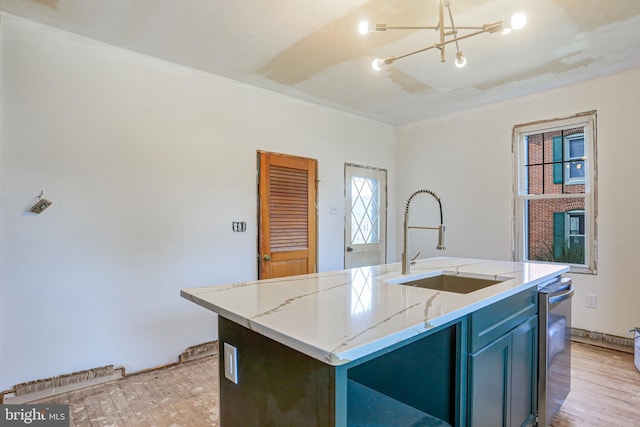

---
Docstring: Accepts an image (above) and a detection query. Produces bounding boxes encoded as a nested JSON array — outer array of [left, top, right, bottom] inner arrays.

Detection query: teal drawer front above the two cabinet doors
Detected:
[[469, 287, 538, 352]]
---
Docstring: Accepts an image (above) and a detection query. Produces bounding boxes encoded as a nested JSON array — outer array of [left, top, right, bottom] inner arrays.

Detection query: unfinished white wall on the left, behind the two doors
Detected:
[[0, 14, 396, 390]]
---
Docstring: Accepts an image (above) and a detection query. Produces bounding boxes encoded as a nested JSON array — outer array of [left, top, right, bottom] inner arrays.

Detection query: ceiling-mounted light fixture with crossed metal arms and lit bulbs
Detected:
[[358, 0, 527, 71]]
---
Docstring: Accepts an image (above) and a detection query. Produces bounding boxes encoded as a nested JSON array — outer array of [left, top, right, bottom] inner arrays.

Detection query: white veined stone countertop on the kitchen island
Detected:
[[181, 257, 569, 366]]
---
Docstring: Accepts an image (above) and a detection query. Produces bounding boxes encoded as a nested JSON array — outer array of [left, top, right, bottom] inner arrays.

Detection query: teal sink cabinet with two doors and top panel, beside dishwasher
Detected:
[[468, 292, 538, 427]]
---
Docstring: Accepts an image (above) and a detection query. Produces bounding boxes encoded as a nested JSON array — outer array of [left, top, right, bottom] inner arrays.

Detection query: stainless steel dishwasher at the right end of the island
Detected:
[[538, 278, 574, 427]]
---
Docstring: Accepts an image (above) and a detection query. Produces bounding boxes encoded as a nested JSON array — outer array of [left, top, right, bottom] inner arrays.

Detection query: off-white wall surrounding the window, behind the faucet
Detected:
[[397, 69, 640, 342]]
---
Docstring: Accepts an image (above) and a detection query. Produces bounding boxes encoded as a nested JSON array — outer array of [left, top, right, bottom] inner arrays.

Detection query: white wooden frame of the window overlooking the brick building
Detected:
[[512, 111, 598, 274]]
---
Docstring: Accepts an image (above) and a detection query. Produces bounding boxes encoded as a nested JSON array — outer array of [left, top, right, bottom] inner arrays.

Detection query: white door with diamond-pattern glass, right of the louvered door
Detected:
[[344, 163, 387, 268]]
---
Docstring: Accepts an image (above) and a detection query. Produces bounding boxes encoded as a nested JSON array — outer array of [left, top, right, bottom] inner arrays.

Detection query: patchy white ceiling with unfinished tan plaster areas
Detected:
[[0, 0, 640, 125]]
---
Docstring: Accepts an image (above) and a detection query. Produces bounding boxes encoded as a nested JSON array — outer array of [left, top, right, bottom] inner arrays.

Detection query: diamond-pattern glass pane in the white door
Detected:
[[351, 176, 380, 244]]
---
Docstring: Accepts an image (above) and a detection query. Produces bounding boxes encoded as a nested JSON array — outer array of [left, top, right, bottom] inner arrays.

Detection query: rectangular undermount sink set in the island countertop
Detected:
[[387, 271, 510, 294]]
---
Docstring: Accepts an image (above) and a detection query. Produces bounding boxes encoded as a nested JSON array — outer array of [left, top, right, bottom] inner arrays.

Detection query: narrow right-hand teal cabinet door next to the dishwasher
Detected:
[[510, 316, 538, 427]]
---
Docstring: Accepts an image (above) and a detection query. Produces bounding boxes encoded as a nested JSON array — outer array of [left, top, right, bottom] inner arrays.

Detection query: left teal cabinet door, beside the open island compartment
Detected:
[[469, 333, 511, 427]]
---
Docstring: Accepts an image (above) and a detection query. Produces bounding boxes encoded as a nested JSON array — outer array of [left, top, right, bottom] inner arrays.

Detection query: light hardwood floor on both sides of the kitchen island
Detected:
[[34, 343, 640, 427]]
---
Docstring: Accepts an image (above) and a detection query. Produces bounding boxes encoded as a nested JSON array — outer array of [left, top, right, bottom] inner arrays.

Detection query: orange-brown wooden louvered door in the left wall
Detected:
[[258, 151, 317, 279]]
